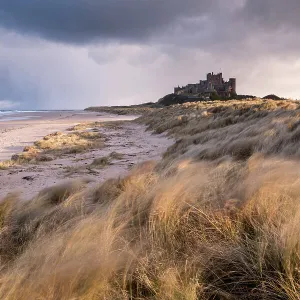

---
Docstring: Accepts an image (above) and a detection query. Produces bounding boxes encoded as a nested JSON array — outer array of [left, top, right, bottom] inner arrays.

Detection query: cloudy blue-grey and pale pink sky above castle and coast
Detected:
[[0, 0, 300, 110]]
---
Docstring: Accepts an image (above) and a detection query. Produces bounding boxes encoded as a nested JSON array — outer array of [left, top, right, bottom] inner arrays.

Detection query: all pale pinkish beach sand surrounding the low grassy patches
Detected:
[[0, 112, 173, 200]]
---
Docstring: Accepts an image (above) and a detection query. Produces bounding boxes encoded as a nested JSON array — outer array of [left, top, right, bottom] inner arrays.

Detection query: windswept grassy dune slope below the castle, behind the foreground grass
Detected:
[[139, 99, 300, 162]]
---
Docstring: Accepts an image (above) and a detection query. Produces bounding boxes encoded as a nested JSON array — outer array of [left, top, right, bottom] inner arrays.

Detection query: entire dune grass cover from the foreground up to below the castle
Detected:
[[0, 99, 300, 300]]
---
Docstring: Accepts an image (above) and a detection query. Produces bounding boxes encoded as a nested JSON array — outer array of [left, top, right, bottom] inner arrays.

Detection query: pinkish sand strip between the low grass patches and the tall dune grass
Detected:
[[0, 122, 173, 199]]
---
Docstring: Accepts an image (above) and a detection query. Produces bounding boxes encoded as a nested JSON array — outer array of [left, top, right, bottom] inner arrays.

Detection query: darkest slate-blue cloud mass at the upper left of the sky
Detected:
[[0, 0, 218, 43]]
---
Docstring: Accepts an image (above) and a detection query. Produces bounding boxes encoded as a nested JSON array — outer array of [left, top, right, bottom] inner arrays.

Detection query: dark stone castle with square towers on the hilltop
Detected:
[[174, 73, 236, 98]]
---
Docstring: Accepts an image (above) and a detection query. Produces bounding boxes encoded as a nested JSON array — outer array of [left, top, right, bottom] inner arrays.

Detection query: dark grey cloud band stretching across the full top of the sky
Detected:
[[0, 0, 300, 46]]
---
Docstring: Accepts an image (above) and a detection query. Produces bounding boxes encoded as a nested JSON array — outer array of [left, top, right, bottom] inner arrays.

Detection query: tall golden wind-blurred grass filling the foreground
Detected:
[[0, 157, 300, 299]]
